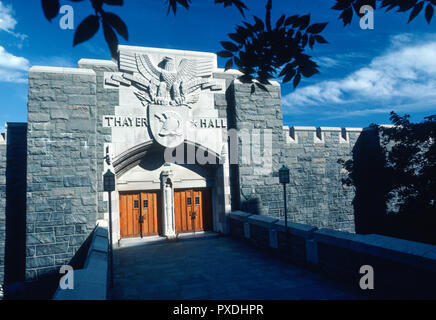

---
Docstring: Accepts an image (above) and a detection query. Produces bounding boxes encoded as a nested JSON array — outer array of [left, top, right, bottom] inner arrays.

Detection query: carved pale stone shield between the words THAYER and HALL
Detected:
[[148, 105, 189, 148]]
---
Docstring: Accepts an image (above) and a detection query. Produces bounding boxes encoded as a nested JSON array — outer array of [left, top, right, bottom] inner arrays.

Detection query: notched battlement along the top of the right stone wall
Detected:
[[283, 126, 364, 144]]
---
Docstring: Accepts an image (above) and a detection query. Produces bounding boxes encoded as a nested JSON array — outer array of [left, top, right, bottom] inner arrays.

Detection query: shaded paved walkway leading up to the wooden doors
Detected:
[[109, 236, 358, 300]]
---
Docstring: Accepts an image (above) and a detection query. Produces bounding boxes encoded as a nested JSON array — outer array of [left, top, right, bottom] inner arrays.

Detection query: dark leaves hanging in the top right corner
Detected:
[[332, 0, 436, 26]]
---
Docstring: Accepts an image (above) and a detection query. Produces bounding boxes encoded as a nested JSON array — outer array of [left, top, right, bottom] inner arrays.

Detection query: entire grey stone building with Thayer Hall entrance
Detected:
[[0, 46, 362, 282]]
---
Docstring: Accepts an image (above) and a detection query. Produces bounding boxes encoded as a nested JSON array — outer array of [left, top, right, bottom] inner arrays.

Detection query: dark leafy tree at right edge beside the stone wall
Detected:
[[342, 112, 436, 216]]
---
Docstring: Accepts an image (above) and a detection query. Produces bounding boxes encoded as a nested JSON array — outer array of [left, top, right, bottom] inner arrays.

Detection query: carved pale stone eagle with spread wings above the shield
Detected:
[[106, 52, 221, 108]]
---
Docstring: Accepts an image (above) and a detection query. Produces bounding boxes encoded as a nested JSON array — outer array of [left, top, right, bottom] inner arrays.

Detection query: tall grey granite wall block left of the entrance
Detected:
[[26, 67, 100, 279]]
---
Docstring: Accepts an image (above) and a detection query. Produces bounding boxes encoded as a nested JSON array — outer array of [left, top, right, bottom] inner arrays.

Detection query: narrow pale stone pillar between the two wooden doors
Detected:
[[160, 168, 176, 238]]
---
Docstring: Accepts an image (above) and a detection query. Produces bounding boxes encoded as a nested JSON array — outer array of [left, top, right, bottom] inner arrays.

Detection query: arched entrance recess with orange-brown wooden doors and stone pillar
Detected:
[[113, 141, 230, 240]]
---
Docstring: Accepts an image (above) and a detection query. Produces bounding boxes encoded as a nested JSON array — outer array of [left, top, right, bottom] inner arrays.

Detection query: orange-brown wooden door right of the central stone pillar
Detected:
[[174, 189, 212, 233]]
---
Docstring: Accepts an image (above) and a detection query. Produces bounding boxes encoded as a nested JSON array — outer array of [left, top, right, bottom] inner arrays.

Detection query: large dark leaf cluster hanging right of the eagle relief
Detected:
[[217, 1, 327, 87]]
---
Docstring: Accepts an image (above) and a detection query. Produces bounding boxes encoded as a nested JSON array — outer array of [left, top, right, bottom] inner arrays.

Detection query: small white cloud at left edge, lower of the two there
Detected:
[[0, 46, 29, 83]]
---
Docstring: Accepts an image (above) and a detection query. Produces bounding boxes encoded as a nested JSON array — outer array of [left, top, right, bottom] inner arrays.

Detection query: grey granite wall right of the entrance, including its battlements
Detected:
[[228, 80, 361, 232]]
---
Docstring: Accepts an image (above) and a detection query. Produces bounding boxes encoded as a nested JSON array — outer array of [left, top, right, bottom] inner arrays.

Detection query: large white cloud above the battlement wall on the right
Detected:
[[283, 34, 436, 116]]
